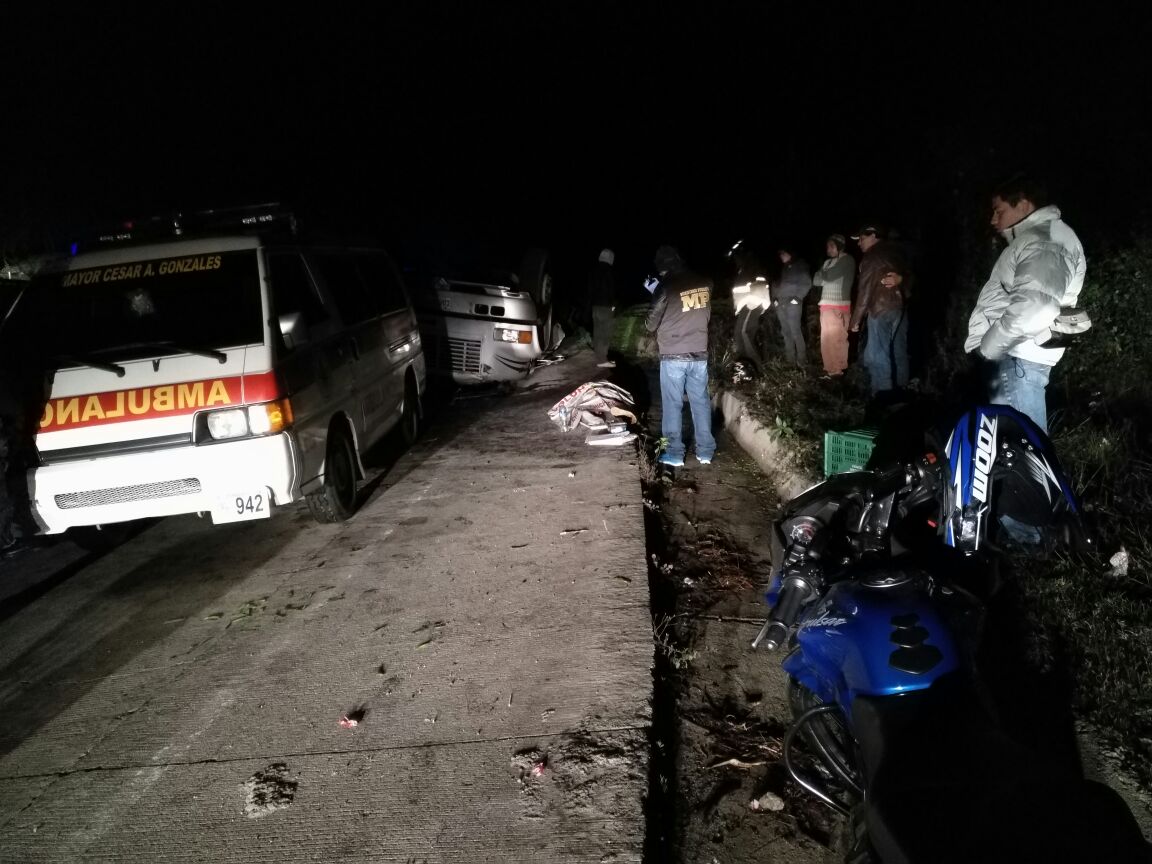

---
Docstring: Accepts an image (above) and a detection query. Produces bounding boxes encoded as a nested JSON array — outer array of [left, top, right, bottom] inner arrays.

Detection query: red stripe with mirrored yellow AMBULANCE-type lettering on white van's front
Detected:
[[40, 372, 280, 432]]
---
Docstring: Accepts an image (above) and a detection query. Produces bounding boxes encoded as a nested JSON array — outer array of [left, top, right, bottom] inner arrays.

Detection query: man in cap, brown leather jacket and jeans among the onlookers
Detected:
[[849, 223, 911, 396]]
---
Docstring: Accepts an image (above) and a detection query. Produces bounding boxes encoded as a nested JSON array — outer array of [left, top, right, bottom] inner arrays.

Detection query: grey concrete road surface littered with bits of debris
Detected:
[[0, 356, 653, 863]]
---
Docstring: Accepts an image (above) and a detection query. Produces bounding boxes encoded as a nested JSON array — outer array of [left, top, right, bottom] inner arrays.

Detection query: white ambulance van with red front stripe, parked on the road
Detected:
[[10, 210, 425, 533]]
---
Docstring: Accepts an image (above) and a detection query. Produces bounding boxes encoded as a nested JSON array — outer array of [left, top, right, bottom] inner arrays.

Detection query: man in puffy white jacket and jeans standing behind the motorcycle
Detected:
[[964, 176, 1085, 432]]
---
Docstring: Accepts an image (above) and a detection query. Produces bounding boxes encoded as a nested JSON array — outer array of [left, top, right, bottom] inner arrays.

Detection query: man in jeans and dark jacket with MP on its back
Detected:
[[646, 245, 717, 468]]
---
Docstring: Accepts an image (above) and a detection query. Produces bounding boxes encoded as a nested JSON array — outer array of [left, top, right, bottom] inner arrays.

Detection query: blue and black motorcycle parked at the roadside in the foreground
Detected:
[[752, 406, 1152, 864]]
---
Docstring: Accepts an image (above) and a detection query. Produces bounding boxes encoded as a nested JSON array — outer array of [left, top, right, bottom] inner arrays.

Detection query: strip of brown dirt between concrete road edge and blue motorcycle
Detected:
[[646, 407, 838, 864]]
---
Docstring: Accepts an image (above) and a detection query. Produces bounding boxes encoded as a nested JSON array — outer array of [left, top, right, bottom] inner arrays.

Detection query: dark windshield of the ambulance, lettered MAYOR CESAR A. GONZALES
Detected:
[[18, 250, 264, 363]]
